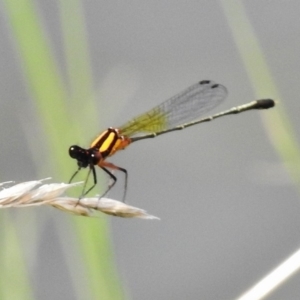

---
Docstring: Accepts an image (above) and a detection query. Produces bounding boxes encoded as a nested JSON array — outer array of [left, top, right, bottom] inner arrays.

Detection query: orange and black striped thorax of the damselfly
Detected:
[[90, 127, 131, 159]]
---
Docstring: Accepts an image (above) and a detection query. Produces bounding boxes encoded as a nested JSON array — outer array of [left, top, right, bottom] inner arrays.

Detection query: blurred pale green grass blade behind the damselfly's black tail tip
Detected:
[[220, 0, 300, 192]]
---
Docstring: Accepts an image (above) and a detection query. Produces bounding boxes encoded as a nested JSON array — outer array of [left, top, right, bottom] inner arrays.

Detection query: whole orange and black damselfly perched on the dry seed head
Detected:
[[69, 80, 275, 201]]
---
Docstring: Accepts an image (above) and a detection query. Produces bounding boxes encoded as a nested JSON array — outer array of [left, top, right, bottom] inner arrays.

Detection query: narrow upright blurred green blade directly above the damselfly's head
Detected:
[[58, 0, 99, 129]]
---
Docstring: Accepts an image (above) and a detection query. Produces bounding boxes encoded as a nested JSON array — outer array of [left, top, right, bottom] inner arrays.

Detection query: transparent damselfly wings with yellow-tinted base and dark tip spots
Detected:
[[119, 80, 227, 136]]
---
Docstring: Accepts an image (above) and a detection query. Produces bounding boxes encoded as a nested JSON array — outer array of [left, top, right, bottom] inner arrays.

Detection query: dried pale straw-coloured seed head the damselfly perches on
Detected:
[[0, 180, 159, 220]]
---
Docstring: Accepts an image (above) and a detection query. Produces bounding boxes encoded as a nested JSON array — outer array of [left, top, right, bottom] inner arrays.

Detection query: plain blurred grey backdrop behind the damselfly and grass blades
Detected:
[[0, 0, 300, 300]]
